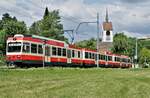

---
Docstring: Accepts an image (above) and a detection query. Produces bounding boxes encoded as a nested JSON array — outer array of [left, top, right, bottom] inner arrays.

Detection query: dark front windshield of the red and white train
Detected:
[[8, 42, 21, 52]]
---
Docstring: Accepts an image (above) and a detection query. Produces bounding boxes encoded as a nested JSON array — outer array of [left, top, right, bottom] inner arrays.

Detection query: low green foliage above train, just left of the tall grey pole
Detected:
[[75, 38, 96, 50]]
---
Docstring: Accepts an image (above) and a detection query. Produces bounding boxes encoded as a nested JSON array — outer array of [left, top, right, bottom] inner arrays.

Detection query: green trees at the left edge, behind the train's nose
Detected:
[[0, 13, 27, 54]]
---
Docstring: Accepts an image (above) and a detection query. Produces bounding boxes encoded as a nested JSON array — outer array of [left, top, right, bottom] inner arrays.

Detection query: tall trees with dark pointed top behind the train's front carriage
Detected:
[[30, 8, 67, 41]]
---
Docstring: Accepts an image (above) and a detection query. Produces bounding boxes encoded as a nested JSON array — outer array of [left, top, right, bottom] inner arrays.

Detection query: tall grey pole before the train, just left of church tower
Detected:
[[96, 13, 100, 67]]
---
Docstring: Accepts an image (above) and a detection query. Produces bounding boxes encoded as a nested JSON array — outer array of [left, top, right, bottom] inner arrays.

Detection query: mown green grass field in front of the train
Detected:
[[0, 68, 150, 98]]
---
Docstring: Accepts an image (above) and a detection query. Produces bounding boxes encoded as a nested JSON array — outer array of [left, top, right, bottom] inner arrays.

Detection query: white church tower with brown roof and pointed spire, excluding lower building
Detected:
[[102, 9, 113, 42]]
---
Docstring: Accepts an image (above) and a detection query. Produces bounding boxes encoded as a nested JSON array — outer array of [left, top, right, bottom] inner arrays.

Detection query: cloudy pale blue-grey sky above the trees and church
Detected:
[[0, 0, 150, 41]]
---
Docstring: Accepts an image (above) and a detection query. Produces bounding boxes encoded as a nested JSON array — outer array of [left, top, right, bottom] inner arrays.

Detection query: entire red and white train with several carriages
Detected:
[[6, 34, 131, 68]]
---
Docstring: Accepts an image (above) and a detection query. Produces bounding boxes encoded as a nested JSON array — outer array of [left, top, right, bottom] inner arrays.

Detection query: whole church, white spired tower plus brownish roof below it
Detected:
[[99, 10, 113, 53]]
